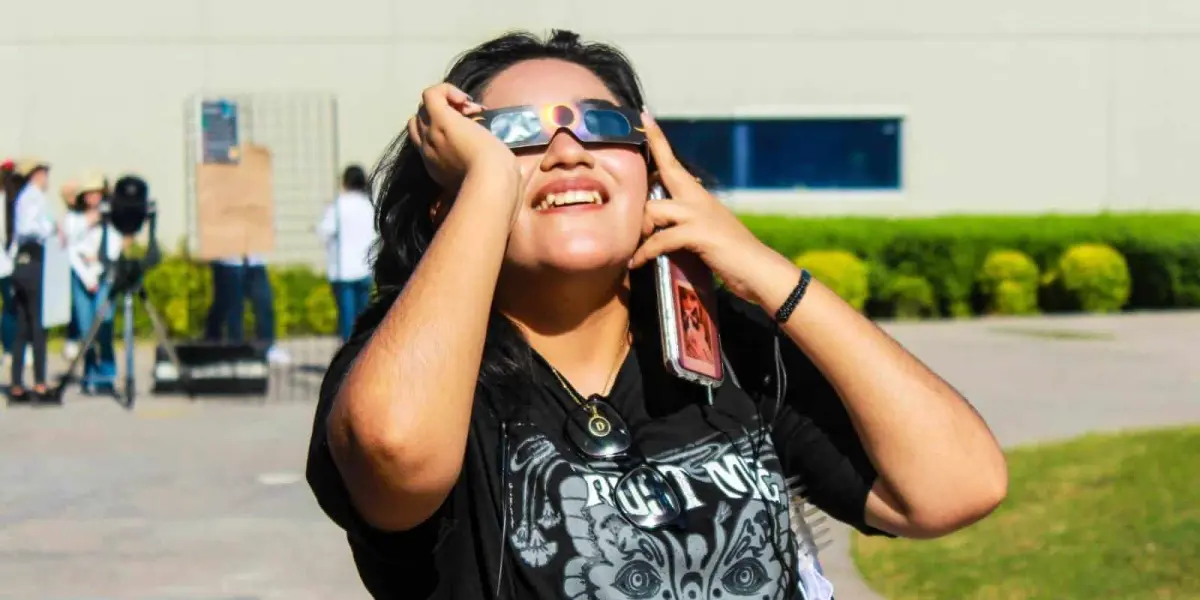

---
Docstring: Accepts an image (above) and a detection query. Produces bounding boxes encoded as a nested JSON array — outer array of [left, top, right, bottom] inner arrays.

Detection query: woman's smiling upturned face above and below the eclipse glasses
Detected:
[[478, 59, 647, 272]]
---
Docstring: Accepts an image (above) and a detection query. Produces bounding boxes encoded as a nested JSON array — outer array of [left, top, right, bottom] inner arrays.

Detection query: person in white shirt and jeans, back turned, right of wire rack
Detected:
[[317, 164, 377, 342]]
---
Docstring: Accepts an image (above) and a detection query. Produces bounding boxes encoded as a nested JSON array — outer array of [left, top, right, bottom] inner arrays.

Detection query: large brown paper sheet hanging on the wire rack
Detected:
[[196, 145, 275, 260]]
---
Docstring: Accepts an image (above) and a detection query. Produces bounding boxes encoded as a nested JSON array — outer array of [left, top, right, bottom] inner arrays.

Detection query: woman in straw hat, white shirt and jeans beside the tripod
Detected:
[[62, 174, 122, 394]]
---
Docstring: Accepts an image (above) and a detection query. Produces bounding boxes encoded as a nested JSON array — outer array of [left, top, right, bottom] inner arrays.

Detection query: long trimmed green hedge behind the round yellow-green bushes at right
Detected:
[[742, 214, 1200, 316]]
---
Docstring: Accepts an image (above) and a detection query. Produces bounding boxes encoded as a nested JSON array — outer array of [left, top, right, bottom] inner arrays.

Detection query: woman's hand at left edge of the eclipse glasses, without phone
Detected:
[[408, 83, 517, 190]]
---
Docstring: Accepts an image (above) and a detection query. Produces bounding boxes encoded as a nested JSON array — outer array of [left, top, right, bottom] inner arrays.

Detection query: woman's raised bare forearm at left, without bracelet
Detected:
[[329, 165, 517, 529]]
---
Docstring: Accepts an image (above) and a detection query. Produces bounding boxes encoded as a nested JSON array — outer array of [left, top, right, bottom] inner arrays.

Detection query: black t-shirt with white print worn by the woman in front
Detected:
[[307, 294, 878, 600]]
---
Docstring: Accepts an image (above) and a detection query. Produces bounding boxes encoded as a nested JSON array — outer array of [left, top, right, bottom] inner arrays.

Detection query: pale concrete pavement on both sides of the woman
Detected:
[[0, 313, 1200, 600]]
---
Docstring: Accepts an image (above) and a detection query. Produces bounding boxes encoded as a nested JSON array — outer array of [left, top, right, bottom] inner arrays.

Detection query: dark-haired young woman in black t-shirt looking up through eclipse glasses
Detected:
[[308, 31, 1007, 600]]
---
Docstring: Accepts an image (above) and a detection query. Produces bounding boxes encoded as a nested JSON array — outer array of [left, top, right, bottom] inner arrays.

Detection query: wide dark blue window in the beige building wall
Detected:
[[659, 119, 902, 190]]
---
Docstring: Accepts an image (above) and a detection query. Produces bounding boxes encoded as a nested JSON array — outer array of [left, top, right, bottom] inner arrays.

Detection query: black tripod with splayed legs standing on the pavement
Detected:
[[54, 209, 191, 409]]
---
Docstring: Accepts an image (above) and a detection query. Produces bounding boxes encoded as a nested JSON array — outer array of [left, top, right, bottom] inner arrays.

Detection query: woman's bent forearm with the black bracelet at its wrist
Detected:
[[756, 250, 1007, 534]]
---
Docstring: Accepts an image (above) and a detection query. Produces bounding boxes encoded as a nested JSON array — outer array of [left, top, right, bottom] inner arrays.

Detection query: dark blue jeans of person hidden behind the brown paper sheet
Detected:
[[204, 263, 275, 344]]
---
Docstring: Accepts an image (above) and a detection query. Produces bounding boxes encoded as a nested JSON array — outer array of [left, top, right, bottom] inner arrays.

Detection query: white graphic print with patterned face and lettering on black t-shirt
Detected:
[[509, 427, 796, 600]]
